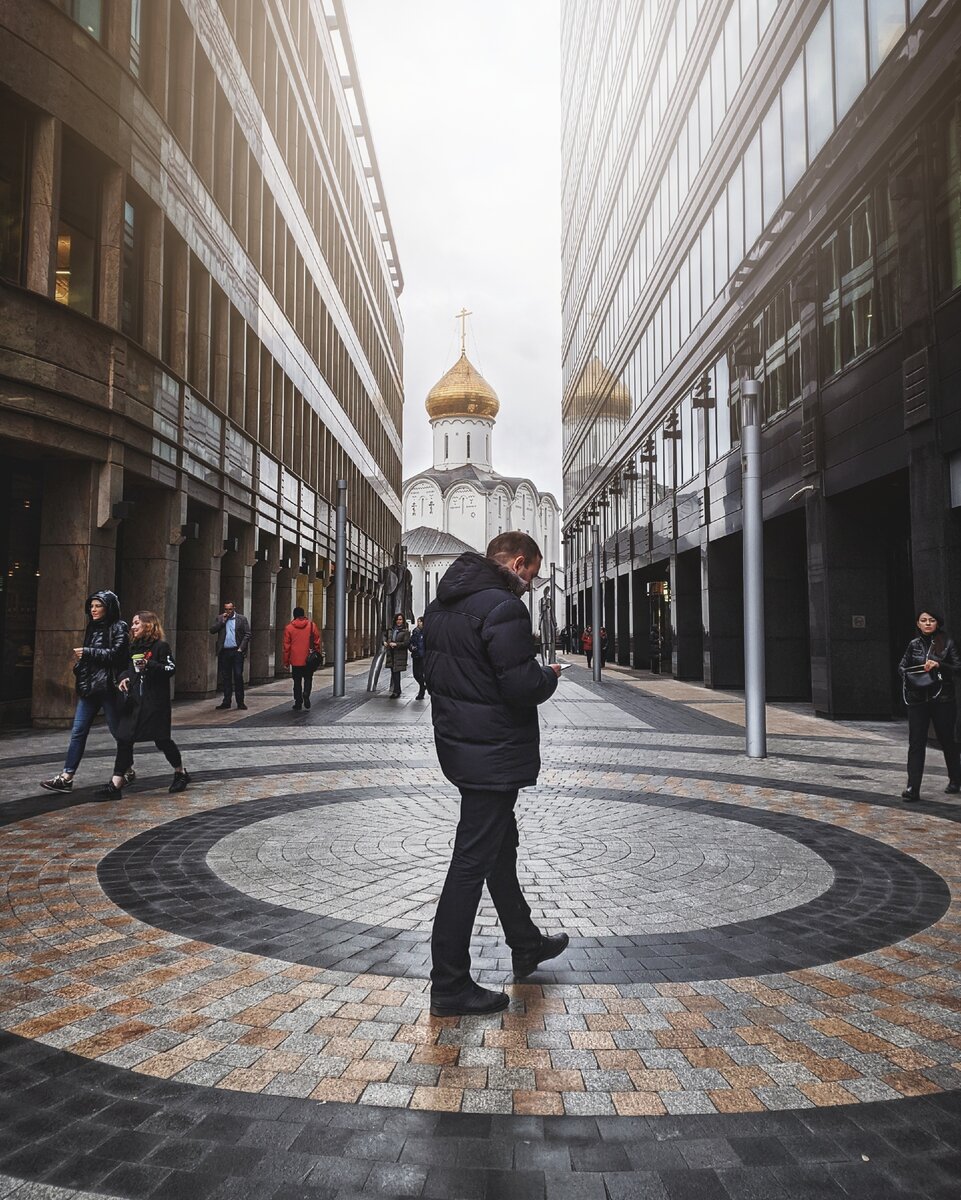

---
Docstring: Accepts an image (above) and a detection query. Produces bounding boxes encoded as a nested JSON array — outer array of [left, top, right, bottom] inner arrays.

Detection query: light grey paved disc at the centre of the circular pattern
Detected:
[[206, 794, 834, 937]]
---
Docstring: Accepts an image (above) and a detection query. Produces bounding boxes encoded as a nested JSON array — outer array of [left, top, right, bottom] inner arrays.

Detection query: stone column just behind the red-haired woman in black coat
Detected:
[[120, 488, 187, 656]]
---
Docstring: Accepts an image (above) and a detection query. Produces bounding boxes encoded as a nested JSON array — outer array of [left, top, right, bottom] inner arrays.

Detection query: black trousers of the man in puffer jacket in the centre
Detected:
[[431, 787, 541, 997]]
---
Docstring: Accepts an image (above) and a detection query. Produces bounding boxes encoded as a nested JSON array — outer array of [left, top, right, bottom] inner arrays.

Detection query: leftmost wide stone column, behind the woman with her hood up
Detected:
[[31, 460, 116, 728]]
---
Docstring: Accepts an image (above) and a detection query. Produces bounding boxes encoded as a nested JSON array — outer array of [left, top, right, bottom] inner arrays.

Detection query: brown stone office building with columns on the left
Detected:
[[0, 0, 403, 724]]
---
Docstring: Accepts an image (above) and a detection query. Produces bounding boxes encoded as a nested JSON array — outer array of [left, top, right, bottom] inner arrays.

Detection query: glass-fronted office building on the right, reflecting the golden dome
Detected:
[[561, 0, 961, 716]]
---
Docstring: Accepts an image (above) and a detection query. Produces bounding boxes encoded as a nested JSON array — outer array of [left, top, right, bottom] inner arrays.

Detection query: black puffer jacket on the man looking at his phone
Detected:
[[424, 551, 557, 792]]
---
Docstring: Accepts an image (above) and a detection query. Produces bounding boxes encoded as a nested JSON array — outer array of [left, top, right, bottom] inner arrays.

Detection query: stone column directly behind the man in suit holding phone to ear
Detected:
[[175, 506, 226, 700]]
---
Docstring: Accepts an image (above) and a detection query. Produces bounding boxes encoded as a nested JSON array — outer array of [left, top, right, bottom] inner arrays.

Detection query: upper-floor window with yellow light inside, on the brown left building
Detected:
[[54, 133, 101, 317]]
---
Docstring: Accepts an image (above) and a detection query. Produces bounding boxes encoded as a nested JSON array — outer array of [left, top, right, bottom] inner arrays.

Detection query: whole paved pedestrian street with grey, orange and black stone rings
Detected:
[[0, 660, 961, 1200]]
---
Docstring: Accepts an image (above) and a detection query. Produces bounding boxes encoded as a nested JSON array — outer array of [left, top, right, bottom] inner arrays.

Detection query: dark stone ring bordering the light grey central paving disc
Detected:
[[98, 787, 950, 984]]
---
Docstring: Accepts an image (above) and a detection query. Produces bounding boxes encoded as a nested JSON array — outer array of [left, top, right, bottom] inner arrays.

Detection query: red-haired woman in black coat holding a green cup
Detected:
[[101, 611, 190, 797]]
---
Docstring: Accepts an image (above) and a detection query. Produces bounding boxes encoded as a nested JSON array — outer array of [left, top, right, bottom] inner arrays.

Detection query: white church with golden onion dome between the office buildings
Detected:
[[403, 348, 564, 624]]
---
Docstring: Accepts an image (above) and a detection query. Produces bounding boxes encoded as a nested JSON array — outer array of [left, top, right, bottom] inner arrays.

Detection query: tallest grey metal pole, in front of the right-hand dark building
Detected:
[[740, 379, 768, 758]]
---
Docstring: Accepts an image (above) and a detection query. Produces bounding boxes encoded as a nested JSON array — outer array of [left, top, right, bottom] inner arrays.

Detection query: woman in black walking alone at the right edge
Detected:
[[899, 608, 961, 804]]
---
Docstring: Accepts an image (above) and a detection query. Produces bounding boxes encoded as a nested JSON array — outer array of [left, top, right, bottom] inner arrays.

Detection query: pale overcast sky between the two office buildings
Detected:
[[346, 0, 561, 502]]
